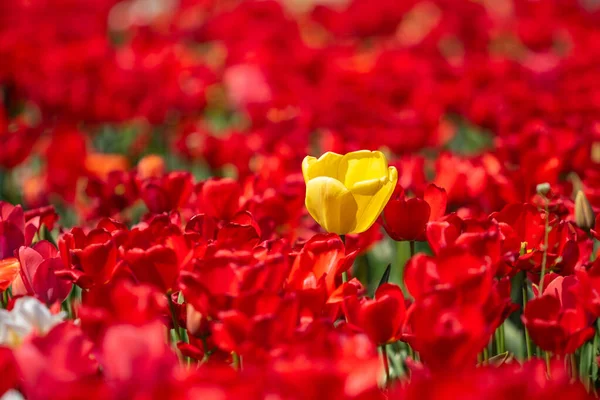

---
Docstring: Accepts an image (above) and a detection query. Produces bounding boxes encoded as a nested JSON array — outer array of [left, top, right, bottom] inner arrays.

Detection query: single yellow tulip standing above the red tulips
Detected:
[[302, 150, 398, 235]]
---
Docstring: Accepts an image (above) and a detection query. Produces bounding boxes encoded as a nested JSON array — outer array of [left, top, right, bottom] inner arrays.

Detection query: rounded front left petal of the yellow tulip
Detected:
[[306, 176, 358, 235]]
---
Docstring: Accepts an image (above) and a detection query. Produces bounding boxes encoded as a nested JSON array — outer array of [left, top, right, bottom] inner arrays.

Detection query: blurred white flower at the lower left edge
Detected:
[[0, 297, 65, 347]]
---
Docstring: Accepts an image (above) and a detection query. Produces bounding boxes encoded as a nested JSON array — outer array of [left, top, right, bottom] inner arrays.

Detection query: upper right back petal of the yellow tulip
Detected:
[[338, 150, 388, 188]]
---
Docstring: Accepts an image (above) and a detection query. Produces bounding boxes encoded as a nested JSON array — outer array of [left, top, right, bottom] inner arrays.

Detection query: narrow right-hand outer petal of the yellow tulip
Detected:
[[351, 167, 398, 233]]
